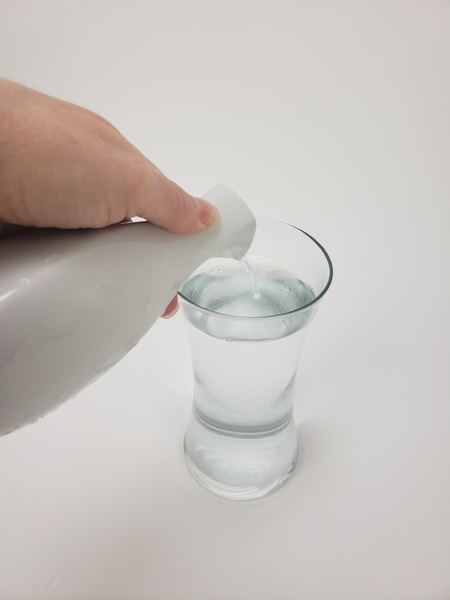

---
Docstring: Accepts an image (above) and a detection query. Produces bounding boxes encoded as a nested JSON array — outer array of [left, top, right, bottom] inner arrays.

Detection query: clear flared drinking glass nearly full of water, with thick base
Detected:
[[180, 219, 333, 500]]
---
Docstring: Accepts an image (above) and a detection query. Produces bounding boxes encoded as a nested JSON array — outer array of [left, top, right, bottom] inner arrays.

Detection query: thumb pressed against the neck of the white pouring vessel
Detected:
[[134, 165, 220, 233]]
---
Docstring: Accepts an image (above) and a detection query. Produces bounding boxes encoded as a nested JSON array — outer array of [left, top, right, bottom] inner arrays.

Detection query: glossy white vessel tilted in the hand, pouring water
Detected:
[[0, 185, 256, 435]]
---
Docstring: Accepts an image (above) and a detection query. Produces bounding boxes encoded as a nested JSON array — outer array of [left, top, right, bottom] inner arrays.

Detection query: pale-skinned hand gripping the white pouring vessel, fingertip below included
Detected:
[[0, 79, 219, 317]]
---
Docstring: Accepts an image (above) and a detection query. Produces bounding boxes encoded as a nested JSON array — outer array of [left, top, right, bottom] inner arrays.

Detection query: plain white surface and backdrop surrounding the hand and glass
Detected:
[[0, 0, 450, 600]]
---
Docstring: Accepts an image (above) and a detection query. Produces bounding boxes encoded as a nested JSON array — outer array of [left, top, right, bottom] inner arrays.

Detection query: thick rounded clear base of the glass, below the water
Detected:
[[184, 413, 299, 500]]
